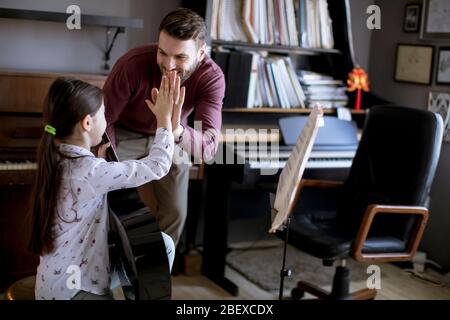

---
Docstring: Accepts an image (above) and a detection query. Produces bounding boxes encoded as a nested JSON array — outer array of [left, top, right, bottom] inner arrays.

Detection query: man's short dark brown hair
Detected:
[[159, 8, 206, 47]]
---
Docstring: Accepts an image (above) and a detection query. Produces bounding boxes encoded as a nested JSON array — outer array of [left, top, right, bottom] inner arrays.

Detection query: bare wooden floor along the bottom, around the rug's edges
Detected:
[[172, 264, 450, 300]]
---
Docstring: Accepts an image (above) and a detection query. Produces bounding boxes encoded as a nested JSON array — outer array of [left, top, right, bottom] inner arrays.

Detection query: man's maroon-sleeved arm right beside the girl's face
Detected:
[[103, 60, 131, 147]]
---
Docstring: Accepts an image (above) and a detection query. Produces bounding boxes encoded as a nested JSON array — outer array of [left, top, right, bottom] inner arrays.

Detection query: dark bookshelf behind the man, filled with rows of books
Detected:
[[183, 0, 366, 115]]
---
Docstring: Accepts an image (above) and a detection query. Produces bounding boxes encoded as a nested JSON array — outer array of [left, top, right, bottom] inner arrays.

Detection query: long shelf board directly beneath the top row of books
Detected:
[[212, 40, 341, 55]]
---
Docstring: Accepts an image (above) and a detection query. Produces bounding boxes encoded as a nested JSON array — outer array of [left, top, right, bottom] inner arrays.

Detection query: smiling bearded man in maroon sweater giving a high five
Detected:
[[103, 8, 225, 244]]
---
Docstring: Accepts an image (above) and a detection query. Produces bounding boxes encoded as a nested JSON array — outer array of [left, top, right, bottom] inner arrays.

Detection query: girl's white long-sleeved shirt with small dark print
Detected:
[[35, 128, 174, 300]]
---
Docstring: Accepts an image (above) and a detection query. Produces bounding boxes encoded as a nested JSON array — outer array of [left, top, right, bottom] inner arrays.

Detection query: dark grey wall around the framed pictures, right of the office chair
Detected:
[[369, 0, 450, 268]]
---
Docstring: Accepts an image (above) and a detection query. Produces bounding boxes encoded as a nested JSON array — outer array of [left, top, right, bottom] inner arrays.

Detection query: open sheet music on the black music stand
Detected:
[[269, 104, 323, 233]]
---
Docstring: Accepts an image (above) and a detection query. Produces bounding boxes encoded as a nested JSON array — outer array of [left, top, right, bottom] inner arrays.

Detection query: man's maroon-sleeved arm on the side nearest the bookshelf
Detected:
[[175, 72, 225, 161]]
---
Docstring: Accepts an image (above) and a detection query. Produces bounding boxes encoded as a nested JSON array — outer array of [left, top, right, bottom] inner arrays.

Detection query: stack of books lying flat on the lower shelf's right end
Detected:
[[297, 70, 348, 108]]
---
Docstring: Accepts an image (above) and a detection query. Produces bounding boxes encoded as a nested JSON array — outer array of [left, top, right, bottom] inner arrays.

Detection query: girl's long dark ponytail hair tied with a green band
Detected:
[[28, 78, 102, 255]]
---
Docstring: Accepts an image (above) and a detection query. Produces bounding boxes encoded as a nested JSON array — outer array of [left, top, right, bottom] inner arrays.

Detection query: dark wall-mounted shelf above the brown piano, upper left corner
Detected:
[[0, 8, 144, 28]]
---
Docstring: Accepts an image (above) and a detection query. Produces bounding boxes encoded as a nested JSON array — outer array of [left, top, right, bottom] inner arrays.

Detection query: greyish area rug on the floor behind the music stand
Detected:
[[227, 241, 383, 293]]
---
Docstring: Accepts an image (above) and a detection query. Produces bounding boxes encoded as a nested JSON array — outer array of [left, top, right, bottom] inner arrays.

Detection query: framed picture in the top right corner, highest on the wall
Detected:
[[420, 0, 450, 41]]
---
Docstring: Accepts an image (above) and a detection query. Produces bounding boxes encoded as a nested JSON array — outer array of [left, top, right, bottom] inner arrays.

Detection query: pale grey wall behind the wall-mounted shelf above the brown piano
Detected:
[[0, 0, 181, 73]]
